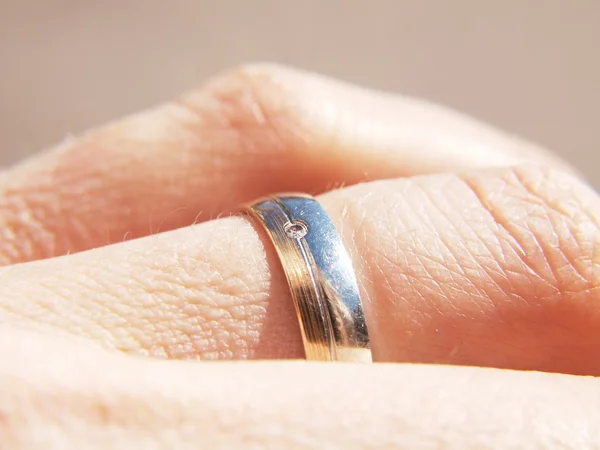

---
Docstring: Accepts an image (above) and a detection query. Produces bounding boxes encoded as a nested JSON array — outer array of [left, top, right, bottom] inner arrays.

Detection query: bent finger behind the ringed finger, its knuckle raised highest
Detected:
[[0, 65, 572, 264]]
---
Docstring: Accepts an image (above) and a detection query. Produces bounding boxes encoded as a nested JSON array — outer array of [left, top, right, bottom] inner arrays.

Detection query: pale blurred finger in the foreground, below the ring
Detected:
[[0, 332, 600, 449]]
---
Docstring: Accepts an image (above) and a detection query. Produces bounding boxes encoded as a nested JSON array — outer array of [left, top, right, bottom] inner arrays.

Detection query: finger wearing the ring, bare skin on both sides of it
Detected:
[[0, 163, 600, 374]]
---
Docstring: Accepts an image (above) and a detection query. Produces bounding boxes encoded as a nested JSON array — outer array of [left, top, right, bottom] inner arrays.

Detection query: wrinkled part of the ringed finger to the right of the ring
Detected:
[[332, 166, 600, 373]]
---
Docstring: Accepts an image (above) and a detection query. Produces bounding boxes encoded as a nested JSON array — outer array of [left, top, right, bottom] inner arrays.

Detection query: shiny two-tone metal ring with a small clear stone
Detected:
[[247, 194, 373, 362]]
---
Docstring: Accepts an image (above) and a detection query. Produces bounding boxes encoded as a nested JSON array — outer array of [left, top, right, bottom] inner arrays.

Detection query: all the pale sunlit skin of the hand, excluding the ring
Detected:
[[0, 64, 600, 449]]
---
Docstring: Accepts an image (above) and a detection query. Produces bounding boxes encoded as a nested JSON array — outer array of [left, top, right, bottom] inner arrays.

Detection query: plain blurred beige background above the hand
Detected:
[[0, 0, 600, 186]]
